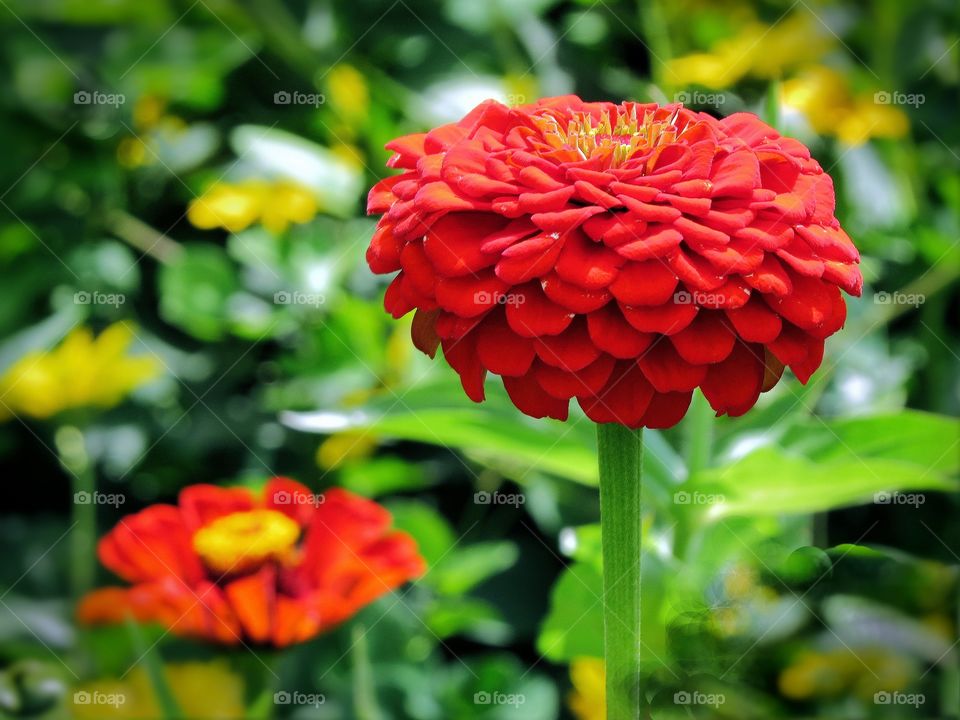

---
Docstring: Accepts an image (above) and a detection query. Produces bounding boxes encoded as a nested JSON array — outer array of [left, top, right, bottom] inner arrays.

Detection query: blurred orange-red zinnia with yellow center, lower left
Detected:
[[78, 478, 424, 646]]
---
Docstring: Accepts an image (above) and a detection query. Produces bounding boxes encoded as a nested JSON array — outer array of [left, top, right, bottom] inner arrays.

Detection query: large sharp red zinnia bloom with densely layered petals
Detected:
[[367, 96, 862, 427]]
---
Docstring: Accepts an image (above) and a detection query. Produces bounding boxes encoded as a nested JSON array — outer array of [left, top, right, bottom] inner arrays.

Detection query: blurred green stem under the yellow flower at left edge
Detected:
[[54, 425, 97, 599]]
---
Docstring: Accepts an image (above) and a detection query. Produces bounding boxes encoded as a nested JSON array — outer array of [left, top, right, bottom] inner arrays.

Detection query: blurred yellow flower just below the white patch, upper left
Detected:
[[187, 180, 319, 233]]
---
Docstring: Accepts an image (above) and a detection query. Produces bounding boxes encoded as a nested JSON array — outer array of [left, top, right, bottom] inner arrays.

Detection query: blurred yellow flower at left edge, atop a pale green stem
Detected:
[[0, 323, 160, 419]]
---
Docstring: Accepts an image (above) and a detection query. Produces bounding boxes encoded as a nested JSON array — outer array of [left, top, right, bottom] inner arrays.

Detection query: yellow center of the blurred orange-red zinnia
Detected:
[[193, 510, 300, 573]]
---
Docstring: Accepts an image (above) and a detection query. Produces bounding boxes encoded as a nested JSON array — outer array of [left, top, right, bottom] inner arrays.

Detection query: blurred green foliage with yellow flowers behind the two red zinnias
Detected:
[[0, 0, 960, 720]]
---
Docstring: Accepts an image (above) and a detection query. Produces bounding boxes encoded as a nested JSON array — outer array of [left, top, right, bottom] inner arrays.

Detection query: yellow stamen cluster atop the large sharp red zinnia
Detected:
[[541, 105, 682, 167]]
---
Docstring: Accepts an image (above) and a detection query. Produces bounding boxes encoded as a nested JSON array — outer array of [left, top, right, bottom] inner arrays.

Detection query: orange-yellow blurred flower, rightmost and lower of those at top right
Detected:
[[781, 66, 910, 145]]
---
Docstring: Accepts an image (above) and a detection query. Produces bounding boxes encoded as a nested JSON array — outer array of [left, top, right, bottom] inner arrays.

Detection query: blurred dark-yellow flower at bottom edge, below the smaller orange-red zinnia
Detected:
[[71, 662, 245, 720]]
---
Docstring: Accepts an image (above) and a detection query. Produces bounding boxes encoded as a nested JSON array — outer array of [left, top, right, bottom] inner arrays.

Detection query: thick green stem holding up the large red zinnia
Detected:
[[597, 423, 643, 720]]
